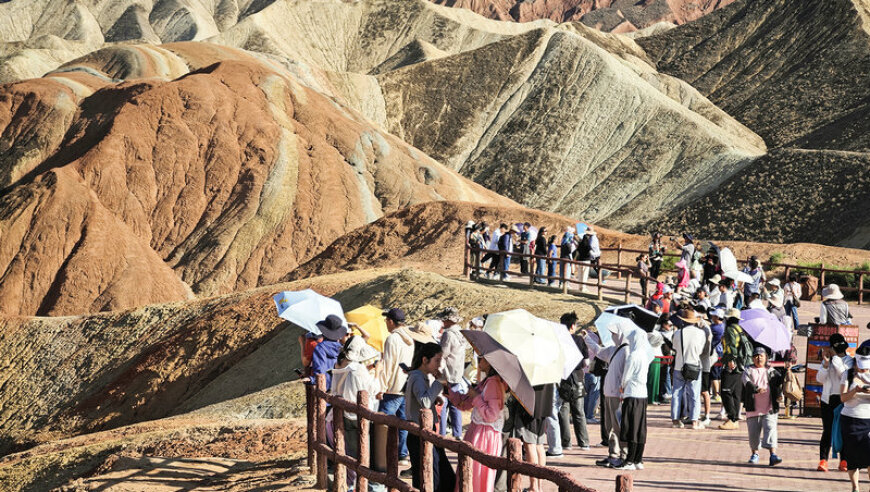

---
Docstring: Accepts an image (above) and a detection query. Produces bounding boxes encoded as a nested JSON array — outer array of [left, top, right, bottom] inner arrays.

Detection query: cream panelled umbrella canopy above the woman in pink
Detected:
[[483, 309, 565, 386]]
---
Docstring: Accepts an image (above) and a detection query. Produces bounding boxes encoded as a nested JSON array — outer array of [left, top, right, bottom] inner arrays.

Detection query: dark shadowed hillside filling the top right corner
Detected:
[[638, 0, 870, 151]]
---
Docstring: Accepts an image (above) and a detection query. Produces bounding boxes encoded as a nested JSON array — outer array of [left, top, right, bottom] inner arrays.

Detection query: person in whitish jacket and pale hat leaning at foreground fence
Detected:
[[330, 336, 386, 491]]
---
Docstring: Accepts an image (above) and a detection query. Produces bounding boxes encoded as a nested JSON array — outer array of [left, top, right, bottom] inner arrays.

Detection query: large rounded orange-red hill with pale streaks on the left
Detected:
[[0, 48, 513, 315]]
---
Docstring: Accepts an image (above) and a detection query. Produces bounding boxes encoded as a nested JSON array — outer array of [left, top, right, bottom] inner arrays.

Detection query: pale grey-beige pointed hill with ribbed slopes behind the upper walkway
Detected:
[[378, 26, 764, 228]]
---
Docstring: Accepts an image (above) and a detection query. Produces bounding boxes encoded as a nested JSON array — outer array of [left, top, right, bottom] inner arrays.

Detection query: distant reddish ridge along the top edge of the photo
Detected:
[[431, 0, 734, 32]]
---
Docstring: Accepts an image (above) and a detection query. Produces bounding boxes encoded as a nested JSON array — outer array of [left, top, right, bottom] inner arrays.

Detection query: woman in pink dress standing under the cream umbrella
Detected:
[[448, 357, 507, 492]]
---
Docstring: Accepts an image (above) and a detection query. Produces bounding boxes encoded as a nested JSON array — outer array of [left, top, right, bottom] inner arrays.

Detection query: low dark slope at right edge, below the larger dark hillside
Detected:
[[649, 149, 870, 249]]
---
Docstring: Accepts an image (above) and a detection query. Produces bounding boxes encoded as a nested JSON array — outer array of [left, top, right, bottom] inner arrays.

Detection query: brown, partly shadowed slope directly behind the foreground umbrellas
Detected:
[[0, 270, 595, 454]]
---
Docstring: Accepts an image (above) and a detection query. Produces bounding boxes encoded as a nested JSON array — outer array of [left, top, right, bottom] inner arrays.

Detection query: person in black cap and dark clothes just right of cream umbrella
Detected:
[[547, 312, 589, 456]]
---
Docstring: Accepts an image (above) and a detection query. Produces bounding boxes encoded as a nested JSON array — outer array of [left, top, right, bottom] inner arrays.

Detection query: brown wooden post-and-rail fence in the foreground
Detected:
[[306, 374, 632, 492]]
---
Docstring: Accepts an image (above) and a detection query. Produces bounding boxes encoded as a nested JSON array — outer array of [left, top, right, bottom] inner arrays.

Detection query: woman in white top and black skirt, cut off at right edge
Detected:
[[840, 346, 870, 492]]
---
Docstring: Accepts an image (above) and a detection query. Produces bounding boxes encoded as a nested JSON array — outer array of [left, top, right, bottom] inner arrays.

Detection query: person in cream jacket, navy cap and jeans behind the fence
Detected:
[[378, 308, 414, 464]]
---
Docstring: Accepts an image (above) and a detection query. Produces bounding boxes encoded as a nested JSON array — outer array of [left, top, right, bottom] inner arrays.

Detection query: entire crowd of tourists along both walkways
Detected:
[[300, 223, 870, 492]]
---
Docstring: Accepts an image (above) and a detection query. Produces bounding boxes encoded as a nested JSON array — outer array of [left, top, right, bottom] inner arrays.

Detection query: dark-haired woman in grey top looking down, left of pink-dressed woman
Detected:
[[405, 342, 456, 492]]
